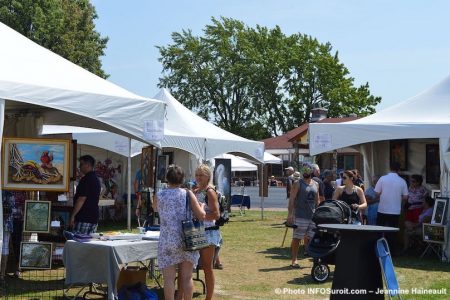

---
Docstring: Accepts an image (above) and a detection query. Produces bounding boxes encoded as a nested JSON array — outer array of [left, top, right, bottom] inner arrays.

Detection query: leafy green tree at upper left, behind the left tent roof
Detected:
[[0, 0, 108, 78]]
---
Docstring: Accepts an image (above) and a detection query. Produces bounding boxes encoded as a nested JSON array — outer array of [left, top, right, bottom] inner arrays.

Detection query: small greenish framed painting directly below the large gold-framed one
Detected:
[[23, 200, 51, 233]]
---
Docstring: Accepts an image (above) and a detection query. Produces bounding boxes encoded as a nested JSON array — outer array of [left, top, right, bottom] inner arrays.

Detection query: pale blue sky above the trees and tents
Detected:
[[91, 0, 450, 110]]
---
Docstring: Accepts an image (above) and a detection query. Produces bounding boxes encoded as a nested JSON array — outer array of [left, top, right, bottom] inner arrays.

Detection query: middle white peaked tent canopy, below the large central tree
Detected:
[[155, 89, 264, 161]]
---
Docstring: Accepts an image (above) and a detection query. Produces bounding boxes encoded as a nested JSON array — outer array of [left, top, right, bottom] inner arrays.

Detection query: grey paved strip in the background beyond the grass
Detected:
[[231, 186, 288, 211]]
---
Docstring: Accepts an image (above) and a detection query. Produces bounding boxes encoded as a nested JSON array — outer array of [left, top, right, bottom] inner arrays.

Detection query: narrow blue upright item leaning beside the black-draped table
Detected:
[[375, 238, 402, 299]]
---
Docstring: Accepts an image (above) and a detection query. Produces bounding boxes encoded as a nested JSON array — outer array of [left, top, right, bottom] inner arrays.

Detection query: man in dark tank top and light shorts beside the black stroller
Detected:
[[287, 164, 319, 268]]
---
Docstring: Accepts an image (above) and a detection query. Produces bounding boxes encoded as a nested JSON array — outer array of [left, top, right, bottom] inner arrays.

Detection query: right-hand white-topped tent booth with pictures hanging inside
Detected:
[[309, 72, 450, 258]]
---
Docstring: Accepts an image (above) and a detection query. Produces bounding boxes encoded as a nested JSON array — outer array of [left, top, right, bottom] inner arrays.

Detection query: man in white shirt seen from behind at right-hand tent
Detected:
[[375, 162, 408, 253]]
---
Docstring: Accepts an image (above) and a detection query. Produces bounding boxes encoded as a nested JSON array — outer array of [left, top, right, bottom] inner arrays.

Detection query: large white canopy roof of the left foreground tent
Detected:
[[0, 23, 165, 246]]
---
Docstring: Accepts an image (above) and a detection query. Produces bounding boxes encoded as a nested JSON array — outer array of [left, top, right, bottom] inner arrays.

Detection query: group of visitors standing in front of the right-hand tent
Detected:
[[285, 162, 434, 268]]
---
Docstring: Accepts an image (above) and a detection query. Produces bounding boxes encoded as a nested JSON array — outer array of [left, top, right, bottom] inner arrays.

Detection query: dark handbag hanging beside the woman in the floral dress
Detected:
[[181, 191, 209, 251]]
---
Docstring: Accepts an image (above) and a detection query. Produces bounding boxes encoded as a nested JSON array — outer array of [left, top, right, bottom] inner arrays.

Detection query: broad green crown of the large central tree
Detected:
[[158, 18, 381, 139]]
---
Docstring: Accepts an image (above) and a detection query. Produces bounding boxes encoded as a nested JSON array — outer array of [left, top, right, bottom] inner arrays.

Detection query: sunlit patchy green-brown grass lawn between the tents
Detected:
[[3, 211, 450, 299]]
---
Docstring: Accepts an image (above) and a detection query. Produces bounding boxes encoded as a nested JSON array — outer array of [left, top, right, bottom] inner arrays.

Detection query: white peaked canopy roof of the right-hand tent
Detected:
[[309, 76, 450, 257]]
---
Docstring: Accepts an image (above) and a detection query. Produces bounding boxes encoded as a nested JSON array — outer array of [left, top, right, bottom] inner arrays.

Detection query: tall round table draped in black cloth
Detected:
[[318, 224, 398, 299]]
